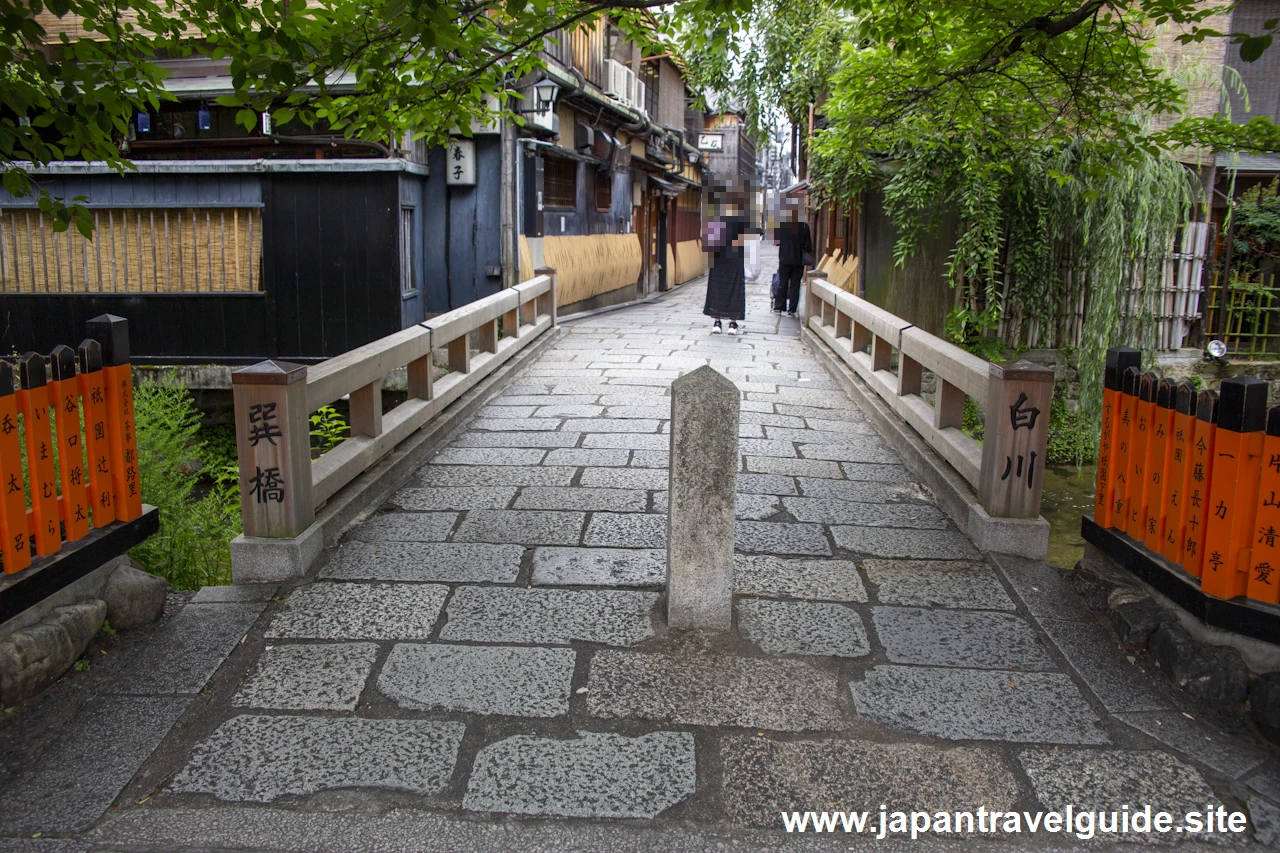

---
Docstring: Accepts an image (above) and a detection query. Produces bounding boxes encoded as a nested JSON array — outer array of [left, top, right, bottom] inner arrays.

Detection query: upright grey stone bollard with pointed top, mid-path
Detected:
[[667, 365, 741, 630]]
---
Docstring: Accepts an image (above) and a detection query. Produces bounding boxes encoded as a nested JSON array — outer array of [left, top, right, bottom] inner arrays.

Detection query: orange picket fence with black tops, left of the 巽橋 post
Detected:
[[0, 314, 142, 575]]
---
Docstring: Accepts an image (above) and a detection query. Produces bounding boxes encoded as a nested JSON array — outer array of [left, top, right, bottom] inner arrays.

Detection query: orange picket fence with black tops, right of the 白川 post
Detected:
[[1093, 347, 1280, 605]]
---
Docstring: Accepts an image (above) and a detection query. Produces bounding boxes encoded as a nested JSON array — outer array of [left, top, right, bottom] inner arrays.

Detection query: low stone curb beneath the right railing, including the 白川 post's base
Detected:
[[800, 327, 1048, 560]]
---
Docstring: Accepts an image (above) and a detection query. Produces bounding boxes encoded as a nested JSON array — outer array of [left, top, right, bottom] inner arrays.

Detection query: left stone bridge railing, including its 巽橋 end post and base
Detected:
[[232, 269, 556, 576]]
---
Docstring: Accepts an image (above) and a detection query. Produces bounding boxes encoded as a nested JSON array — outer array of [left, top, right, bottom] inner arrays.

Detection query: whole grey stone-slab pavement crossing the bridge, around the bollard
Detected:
[[0, 242, 1280, 850]]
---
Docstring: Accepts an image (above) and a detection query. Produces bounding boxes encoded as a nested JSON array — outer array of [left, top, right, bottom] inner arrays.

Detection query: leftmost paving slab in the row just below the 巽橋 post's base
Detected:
[[266, 581, 449, 639]]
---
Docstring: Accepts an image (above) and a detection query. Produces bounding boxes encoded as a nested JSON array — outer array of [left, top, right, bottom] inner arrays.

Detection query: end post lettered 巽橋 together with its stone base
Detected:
[[232, 361, 323, 583]]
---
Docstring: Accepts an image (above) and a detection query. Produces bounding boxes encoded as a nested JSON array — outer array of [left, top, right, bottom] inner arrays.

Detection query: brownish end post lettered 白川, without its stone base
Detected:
[[978, 361, 1053, 519]]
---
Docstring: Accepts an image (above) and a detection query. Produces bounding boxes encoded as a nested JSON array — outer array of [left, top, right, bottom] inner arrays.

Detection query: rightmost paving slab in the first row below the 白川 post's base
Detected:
[[863, 560, 1015, 610]]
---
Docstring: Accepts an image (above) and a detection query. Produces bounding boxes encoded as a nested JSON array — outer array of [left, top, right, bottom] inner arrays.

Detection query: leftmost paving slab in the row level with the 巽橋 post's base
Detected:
[[320, 540, 525, 584]]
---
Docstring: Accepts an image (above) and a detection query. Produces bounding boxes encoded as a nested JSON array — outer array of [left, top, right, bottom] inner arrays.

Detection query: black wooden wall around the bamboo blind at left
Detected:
[[0, 172, 404, 364]]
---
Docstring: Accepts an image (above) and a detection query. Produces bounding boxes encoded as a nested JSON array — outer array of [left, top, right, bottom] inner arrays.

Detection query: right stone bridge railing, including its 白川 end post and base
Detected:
[[805, 270, 1053, 557]]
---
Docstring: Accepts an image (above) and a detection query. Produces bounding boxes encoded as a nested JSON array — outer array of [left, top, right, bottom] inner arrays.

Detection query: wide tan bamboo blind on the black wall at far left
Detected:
[[0, 207, 262, 293]]
